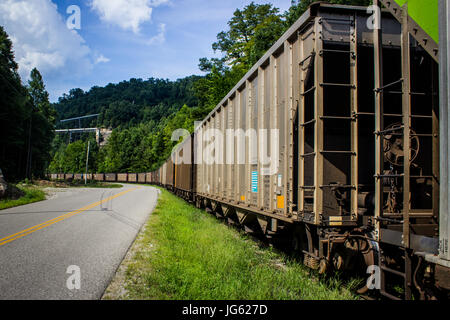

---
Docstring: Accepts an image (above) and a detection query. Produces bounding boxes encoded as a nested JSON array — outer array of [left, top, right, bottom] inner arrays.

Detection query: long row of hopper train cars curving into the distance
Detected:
[[51, 1, 450, 299]]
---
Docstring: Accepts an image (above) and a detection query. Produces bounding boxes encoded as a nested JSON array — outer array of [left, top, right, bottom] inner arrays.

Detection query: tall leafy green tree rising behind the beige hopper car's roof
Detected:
[[194, 2, 285, 115]]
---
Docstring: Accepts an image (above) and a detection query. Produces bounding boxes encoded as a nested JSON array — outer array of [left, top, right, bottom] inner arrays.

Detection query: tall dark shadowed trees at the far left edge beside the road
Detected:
[[0, 26, 56, 180]]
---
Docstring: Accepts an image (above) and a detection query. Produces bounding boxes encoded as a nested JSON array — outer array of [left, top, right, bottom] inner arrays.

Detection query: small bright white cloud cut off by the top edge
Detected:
[[90, 0, 169, 33]]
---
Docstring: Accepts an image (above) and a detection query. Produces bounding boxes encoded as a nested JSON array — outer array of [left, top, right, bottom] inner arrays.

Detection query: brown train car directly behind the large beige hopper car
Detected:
[[172, 135, 195, 201]]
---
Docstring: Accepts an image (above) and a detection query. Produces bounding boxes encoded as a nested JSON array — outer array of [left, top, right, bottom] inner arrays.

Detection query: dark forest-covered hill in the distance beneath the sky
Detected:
[[53, 76, 200, 128]]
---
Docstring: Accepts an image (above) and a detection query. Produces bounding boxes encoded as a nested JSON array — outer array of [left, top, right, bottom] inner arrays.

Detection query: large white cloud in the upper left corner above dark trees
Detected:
[[0, 0, 93, 79]]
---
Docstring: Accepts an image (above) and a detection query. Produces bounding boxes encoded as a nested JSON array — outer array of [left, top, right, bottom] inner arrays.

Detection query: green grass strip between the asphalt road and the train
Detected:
[[104, 190, 356, 300]]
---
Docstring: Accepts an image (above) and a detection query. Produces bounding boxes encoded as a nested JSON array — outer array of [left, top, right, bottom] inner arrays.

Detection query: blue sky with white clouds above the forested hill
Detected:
[[0, 0, 291, 101]]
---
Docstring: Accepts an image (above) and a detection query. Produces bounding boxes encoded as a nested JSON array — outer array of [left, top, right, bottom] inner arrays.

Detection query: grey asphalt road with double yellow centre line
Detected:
[[0, 185, 158, 300]]
